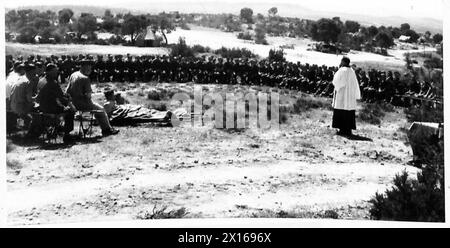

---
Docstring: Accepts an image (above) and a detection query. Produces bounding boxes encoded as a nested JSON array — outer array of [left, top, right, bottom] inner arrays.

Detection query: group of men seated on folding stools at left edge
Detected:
[[6, 60, 119, 142]]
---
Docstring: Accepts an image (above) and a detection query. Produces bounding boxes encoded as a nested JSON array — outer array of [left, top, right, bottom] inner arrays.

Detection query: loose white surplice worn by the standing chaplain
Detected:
[[333, 67, 361, 110]]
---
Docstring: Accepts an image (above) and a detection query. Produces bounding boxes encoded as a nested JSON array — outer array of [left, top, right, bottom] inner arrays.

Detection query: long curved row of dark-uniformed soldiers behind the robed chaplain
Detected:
[[6, 54, 442, 107]]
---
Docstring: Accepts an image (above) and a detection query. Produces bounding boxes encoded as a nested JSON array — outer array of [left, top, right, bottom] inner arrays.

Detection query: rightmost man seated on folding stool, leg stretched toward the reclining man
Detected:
[[66, 60, 119, 136]]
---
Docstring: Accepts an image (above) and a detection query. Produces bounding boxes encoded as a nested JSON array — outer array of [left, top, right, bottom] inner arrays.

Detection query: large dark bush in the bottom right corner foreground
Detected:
[[369, 138, 445, 222]]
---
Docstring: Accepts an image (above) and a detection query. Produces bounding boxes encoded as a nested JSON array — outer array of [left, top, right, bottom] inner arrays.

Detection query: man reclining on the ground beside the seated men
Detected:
[[103, 90, 187, 126]]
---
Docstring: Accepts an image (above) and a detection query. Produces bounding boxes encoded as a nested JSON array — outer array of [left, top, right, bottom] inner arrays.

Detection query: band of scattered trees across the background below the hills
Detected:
[[5, 7, 443, 50]]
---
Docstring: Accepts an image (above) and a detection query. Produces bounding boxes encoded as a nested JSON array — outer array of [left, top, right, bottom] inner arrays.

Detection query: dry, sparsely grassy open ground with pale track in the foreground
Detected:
[[7, 83, 417, 225]]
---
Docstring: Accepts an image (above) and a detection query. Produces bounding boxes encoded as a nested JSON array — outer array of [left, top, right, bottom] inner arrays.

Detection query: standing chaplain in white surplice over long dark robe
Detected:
[[332, 57, 361, 135]]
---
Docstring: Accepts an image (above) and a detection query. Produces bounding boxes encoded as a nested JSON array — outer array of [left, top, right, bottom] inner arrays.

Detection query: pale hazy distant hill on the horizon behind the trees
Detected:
[[7, 0, 443, 33]]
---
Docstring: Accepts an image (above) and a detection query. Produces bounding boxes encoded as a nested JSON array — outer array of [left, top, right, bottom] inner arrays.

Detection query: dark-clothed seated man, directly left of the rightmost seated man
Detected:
[[36, 64, 76, 143]]
